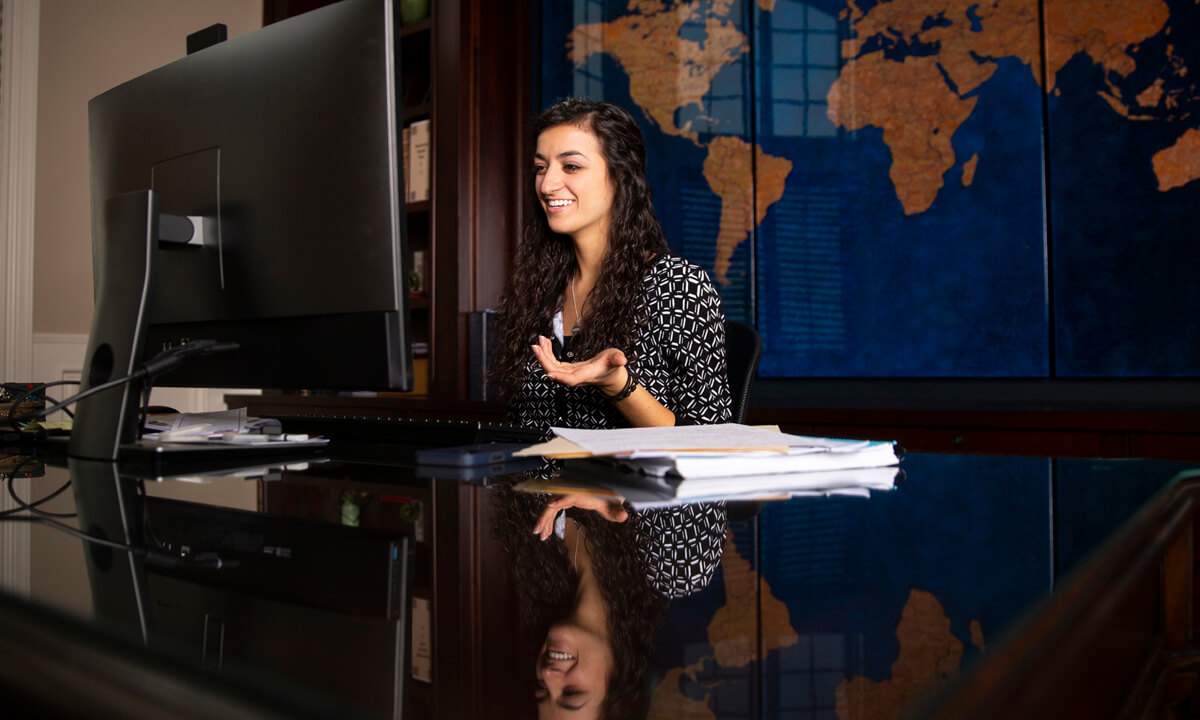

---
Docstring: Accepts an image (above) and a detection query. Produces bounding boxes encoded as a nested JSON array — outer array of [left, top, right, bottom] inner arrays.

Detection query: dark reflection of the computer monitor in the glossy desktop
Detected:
[[70, 460, 414, 716]]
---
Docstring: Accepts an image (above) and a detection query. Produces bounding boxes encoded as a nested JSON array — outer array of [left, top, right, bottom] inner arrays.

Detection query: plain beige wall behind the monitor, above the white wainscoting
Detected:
[[34, 0, 263, 342]]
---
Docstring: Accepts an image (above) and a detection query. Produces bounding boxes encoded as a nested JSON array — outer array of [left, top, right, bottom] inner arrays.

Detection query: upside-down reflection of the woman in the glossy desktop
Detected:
[[493, 484, 726, 720]]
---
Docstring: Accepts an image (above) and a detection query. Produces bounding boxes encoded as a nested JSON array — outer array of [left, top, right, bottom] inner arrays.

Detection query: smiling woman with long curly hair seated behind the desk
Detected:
[[496, 100, 731, 428]]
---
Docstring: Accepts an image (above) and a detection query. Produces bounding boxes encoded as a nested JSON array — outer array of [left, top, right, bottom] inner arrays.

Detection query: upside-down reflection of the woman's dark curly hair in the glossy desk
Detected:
[[493, 484, 670, 719]]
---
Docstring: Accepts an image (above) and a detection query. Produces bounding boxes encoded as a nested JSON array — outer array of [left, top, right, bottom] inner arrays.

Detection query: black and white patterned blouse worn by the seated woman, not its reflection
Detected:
[[509, 254, 731, 430]]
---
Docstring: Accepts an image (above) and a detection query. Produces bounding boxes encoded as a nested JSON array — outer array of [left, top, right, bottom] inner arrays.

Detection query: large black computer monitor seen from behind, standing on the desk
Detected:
[[70, 0, 413, 460]]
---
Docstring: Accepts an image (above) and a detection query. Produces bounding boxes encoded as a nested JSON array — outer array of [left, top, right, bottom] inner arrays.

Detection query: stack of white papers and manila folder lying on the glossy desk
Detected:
[[518, 422, 900, 478]]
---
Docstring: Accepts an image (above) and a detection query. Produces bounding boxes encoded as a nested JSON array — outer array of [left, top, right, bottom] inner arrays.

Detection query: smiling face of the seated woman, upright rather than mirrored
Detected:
[[534, 125, 616, 247]]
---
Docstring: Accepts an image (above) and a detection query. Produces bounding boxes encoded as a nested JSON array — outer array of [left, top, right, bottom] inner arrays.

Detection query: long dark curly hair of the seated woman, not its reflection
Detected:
[[492, 98, 667, 397]]
